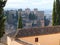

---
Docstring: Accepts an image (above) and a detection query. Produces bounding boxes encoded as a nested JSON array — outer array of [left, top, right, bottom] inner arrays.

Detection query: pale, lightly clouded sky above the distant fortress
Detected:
[[4, 0, 54, 10]]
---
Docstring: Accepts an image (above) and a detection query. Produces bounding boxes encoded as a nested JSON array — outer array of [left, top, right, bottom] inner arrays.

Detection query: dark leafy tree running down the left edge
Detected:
[[0, 0, 7, 42]]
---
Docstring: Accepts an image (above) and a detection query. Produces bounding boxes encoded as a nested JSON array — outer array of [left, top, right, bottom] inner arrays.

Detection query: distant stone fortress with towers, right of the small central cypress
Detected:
[[18, 8, 44, 28]]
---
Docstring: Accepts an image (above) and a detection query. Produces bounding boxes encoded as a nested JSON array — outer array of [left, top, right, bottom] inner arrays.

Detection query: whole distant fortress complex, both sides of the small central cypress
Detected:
[[4, 8, 44, 28]]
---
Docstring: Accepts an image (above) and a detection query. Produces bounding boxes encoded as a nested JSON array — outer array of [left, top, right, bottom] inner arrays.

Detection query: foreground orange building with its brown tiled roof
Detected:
[[7, 26, 60, 45]]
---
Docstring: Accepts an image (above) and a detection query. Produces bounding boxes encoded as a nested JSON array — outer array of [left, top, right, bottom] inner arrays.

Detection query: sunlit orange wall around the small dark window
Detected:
[[19, 33, 60, 45]]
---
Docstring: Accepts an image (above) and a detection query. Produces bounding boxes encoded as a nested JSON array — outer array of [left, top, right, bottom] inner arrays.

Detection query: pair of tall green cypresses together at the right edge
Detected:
[[52, 0, 60, 26]]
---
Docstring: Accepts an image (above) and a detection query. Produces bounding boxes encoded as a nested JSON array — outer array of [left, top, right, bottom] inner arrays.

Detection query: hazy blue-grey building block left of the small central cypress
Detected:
[[4, 10, 18, 27]]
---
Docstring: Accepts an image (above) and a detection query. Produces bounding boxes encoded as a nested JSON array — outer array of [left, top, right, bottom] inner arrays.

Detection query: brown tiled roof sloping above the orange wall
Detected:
[[9, 26, 60, 38]]
